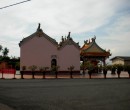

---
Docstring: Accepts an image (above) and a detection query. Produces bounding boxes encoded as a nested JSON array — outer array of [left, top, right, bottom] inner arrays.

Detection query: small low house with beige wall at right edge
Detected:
[[111, 56, 130, 65]]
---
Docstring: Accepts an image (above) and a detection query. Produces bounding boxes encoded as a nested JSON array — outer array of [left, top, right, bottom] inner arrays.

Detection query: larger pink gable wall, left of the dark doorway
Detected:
[[20, 36, 57, 70]]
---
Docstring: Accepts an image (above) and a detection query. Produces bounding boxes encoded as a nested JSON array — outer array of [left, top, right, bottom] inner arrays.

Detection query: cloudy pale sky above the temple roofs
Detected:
[[0, 0, 130, 58]]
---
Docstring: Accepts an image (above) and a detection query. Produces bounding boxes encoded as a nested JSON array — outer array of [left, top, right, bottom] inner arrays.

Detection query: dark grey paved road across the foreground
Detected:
[[0, 78, 130, 110]]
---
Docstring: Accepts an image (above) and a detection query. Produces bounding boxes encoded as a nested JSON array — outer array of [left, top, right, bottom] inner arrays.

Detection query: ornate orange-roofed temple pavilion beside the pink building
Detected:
[[80, 37, 111, 66]]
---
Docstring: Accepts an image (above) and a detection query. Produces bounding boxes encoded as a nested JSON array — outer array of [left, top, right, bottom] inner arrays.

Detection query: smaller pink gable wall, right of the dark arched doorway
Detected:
[[59, 45, 80, 71]]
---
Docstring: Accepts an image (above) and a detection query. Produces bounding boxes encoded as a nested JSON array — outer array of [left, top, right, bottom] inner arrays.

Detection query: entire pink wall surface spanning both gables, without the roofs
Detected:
[[20, 36, 80, 71]]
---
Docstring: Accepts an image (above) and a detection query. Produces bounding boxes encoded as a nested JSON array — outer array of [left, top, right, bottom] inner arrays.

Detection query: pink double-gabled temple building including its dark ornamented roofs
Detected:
[[19, 24, 80, 72]]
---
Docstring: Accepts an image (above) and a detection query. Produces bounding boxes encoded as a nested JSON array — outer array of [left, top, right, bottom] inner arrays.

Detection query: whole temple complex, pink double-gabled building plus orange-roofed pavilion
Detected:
[[19, 24, 111, 73]]
